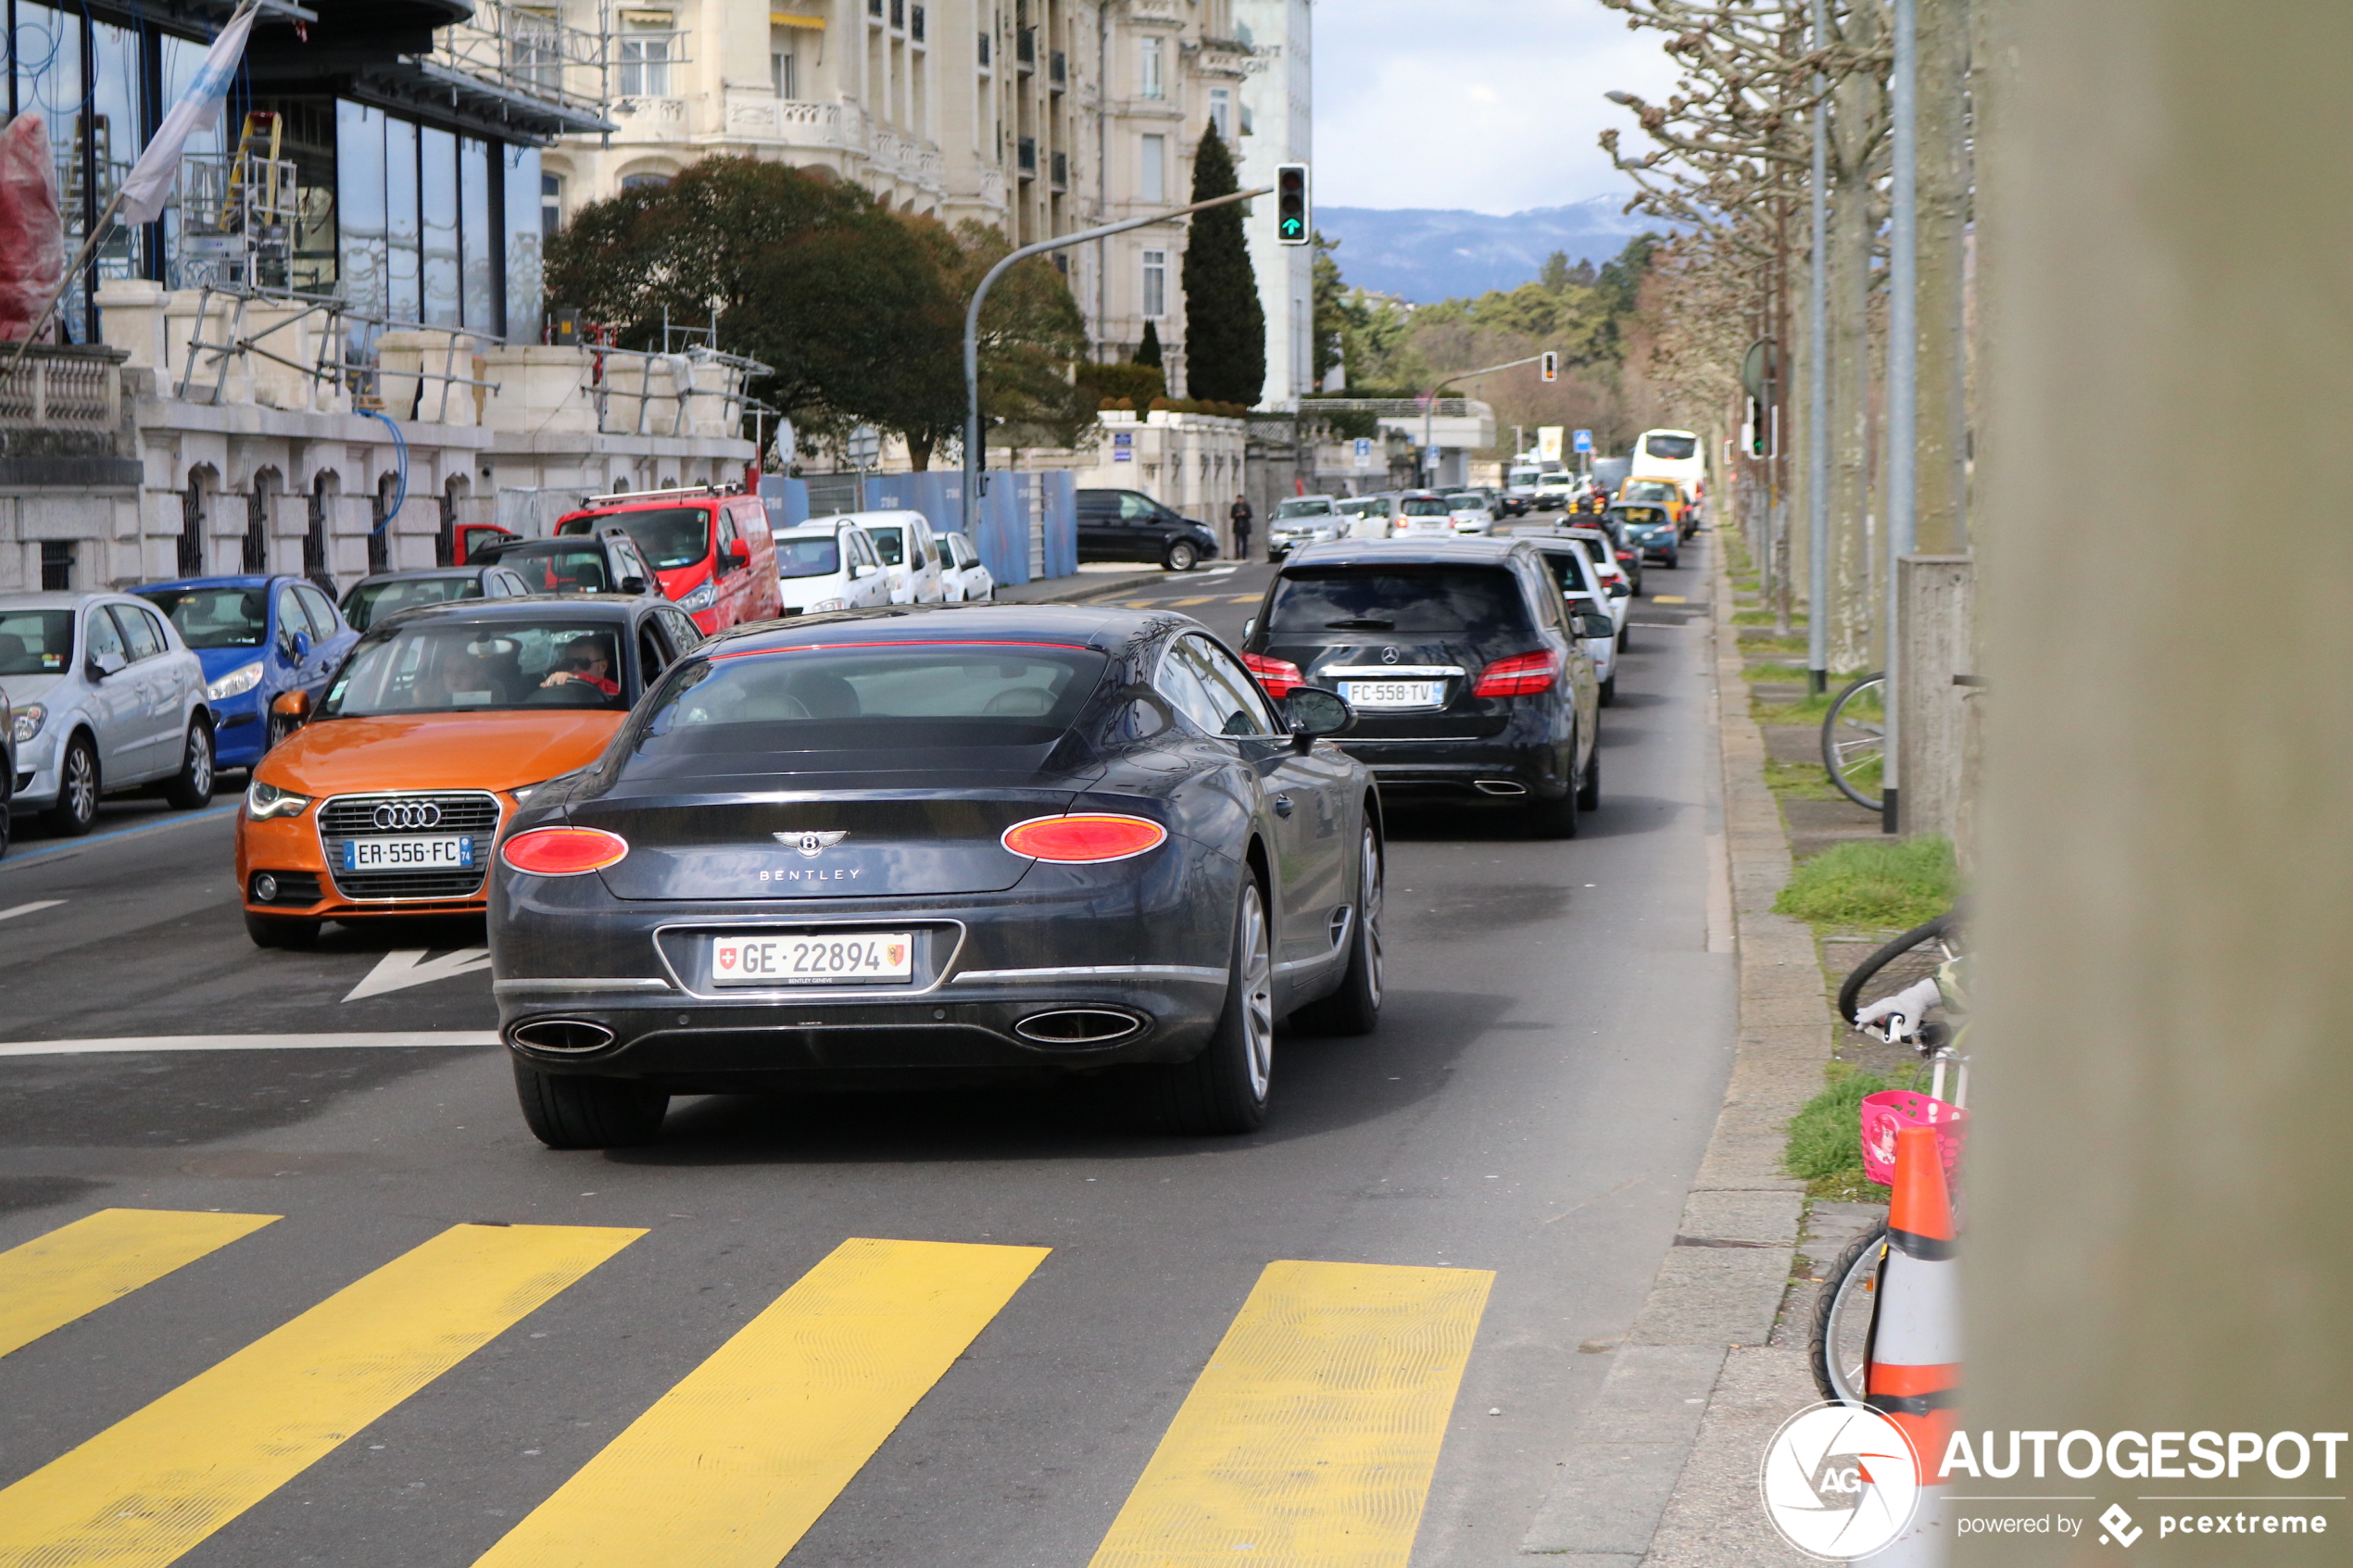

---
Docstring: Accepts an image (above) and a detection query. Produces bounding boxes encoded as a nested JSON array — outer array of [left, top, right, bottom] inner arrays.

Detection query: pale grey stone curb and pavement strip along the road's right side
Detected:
[[1520, 545, 1831, 1568]]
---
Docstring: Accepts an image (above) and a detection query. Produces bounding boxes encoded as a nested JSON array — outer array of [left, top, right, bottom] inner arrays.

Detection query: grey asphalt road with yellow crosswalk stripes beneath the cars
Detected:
[[0, 550, 1731, 1568]]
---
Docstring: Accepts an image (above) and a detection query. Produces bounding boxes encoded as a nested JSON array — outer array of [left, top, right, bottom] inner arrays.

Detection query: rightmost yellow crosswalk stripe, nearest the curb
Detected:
[[1092, 1262, 1494, 1568]]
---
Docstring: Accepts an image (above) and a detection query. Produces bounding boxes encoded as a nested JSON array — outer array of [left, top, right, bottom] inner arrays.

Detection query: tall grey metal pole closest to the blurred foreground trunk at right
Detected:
[[1880, 0, 1920, 833]]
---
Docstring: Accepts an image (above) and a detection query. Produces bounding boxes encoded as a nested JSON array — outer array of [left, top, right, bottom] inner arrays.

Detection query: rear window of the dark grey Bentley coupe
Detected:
[[635, 642, 1111, 757]]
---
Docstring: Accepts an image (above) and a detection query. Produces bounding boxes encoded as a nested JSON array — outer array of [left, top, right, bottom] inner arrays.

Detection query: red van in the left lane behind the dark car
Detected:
[[555, 484, 784, 633]]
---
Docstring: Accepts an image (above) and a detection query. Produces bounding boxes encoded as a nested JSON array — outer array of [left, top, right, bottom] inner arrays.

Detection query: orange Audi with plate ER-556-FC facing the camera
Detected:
[[238, 595, 703, 947]]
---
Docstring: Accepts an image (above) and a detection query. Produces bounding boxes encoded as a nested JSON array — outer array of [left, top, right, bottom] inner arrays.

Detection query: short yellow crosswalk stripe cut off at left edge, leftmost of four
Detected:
[[0, 1209, 278, 1357]]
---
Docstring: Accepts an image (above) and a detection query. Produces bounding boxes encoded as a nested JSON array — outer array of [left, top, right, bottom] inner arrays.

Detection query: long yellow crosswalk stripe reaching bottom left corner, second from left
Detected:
[[0, 1224, 645, 1568]]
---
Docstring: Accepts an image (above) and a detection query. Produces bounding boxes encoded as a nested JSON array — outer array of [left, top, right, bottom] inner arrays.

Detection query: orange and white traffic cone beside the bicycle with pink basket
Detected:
[[1864, 1126, 1960, 1568]]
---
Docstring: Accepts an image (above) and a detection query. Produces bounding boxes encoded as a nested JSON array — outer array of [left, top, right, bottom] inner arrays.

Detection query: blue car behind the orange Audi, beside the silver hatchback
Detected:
[[134, 576, 360, 769]]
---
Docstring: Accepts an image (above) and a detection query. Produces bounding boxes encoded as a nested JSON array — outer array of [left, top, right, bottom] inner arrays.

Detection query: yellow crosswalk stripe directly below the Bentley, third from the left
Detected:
[[475, 1236, 1047, 1568]]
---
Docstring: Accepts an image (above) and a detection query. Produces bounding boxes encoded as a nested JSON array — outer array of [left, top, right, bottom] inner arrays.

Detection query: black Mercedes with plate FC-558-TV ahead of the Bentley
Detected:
[[1242, 538, 1612, 837]]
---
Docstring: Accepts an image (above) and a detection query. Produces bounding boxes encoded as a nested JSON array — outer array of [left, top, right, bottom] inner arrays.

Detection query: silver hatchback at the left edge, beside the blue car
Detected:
[[0, 593, 212, 834]]
